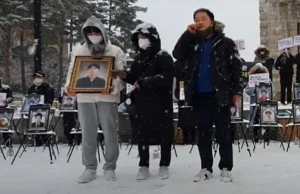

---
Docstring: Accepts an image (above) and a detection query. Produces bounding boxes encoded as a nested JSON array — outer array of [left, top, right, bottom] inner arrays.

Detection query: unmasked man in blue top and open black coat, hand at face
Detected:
[[173, 8, 243, 182]]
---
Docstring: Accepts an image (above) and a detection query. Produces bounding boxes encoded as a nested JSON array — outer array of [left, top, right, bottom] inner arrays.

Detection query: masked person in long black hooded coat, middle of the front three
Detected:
[[112, 23, 174, 180]]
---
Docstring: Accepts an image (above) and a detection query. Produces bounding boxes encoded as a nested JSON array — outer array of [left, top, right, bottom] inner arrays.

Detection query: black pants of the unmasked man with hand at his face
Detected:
[[194, 93, 233, 172]]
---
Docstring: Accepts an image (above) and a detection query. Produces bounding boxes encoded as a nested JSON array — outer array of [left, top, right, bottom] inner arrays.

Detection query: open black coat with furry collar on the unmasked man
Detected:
[[173, 21, 243, 106]]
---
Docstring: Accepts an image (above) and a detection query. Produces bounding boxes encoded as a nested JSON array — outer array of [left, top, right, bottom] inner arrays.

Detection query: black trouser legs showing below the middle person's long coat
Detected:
[[138, 143, 172, 167]]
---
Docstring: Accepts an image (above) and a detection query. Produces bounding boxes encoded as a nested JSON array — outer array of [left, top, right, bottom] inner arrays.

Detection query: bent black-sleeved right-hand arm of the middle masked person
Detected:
[[138, 53, 174, 90]]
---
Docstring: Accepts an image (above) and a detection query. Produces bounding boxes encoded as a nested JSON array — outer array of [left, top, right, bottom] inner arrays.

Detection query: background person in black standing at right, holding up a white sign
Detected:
[[275, 49, 295, 104]]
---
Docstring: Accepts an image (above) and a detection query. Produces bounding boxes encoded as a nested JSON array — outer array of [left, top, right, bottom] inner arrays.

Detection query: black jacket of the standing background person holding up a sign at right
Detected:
[[275, 53, 295, 76]]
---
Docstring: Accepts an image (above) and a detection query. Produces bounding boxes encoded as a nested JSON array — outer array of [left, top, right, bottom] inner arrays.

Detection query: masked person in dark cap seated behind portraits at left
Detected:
[[27, 71, 55, 146]]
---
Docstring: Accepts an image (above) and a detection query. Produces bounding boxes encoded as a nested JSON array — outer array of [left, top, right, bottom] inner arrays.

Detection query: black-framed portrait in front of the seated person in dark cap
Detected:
[[26, 104, 50, 133]]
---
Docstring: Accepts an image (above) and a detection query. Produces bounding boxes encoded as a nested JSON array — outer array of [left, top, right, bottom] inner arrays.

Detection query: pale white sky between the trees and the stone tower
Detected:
[[138, 0, 260, 61]]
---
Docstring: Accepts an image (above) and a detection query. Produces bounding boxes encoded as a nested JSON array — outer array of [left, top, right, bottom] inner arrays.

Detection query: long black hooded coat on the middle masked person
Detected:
[[125, 23, 174, 144]]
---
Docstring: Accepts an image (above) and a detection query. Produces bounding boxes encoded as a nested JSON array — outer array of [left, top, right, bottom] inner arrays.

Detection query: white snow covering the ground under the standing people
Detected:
[[0, 142, 300, 194]]
